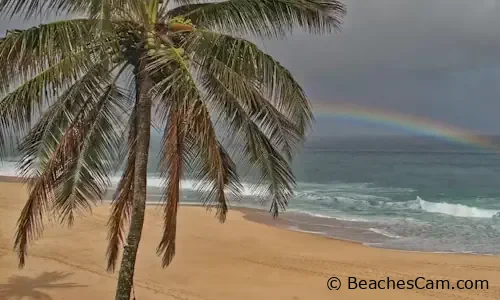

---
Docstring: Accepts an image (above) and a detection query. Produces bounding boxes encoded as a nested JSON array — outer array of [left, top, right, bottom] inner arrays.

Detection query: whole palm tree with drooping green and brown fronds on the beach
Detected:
[[0, 0, 344, 299]]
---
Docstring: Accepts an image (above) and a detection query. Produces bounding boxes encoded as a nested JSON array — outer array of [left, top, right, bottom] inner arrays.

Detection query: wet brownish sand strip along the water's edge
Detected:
[[0, 175, 499, 257]]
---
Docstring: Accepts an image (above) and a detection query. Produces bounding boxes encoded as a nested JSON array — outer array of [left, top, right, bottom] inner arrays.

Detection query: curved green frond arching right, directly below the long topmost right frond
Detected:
[[186, 31, 313, 136]]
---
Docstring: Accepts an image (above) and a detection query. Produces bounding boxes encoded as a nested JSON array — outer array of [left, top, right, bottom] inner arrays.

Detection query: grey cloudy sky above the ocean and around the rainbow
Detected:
[[0, 0, 500, 136]]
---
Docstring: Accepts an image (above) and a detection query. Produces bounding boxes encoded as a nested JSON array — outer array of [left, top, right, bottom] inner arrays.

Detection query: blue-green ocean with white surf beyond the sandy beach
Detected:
[[0, 136, 500, 255]]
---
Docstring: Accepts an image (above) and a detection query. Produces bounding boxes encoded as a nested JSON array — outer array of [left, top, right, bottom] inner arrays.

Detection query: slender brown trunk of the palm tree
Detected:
[[115, 68, 152, 300]]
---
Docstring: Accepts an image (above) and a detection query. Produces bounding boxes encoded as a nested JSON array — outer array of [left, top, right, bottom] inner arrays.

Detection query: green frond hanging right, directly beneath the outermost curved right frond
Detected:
[[184, 32, 300, 160]]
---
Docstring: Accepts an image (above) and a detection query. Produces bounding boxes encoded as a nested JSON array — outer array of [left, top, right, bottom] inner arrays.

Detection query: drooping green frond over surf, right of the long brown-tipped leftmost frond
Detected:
[[54, 83, 124, 225]]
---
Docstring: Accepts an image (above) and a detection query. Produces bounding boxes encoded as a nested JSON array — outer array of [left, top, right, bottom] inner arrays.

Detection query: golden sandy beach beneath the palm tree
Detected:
[[0, 182, 500, 300]]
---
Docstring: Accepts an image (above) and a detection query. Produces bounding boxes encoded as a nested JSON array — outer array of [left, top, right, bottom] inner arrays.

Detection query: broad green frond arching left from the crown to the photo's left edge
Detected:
[[0, 20, 119, 156]]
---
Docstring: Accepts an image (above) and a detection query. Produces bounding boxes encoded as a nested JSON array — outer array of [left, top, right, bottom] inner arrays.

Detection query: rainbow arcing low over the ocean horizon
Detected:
[[312, 102, 500, 151]]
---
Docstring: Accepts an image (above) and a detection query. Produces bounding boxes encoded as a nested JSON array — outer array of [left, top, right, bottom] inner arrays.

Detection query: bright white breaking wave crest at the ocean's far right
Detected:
[[416, 196, 499, 218]]
